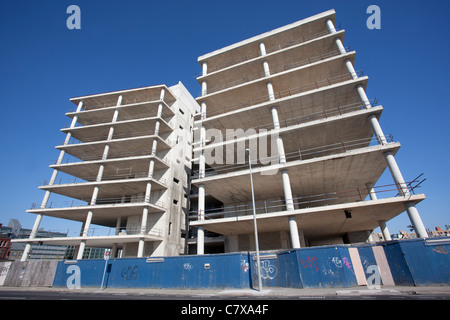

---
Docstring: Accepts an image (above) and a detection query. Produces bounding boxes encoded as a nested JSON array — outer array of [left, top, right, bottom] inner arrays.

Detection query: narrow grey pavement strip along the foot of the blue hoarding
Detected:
[[0, 286, 450, 300]]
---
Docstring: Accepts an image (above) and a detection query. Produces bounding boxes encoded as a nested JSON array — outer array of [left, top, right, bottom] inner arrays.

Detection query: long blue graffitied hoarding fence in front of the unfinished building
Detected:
[[0, 237, 450, 289]]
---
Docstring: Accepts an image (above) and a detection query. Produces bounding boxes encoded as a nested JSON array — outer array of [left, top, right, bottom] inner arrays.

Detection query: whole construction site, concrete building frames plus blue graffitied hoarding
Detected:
[[2, 10, 450, 288]]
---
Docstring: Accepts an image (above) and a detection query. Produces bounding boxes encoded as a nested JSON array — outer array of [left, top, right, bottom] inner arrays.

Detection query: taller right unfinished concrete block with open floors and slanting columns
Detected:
[[190, 10, 427, 254]]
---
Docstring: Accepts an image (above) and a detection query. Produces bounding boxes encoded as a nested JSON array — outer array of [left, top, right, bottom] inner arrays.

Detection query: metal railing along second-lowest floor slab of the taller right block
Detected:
[[193, 135, 393, 179]]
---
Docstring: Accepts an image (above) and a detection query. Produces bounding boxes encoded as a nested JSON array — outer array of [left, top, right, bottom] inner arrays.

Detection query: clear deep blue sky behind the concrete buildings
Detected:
[[0, 0, 450, 233]]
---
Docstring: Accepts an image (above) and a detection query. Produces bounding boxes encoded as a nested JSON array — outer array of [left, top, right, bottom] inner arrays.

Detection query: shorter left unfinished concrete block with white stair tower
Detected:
[[16, 82, 199, 261]]
